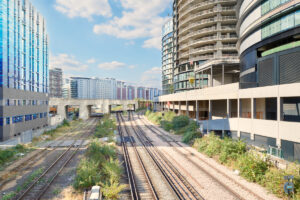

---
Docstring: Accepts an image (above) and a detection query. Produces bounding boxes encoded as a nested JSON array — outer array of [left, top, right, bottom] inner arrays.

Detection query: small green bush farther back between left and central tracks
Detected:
[[94, 115, 117, 139]]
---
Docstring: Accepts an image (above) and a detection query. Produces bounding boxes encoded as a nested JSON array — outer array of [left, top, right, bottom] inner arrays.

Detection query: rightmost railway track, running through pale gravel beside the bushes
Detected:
[[138, 115, 264, 200]]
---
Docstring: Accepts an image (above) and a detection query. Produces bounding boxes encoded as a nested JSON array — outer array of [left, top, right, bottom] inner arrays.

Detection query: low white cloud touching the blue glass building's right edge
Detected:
[[50, 54, 88, 71]]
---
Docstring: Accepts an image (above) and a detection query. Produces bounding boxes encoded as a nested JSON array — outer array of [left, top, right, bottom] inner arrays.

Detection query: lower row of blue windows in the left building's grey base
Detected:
[[0, 112, 47, 126]]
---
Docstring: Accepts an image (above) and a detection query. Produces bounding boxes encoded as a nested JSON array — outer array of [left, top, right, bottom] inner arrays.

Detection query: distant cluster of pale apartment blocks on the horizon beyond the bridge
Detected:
[[50, 73, 161, 100]]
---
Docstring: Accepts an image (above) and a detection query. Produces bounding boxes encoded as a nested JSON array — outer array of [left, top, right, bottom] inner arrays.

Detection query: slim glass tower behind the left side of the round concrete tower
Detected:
[[162, 19, 174, 94]]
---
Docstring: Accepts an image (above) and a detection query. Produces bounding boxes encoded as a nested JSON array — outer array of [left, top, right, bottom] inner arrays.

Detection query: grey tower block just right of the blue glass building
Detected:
[[49, 68, 63, 98]]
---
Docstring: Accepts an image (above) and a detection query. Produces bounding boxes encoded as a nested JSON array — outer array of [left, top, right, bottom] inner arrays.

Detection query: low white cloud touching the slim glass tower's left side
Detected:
[[140, 67, 161, 88]]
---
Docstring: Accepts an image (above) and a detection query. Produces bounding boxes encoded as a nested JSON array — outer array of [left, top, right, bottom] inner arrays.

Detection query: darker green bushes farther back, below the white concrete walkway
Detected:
[[145, 111, 202, 144]]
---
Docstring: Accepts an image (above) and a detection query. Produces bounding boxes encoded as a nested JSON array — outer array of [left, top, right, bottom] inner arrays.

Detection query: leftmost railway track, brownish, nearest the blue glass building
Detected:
[[0, 120, 86, 190]]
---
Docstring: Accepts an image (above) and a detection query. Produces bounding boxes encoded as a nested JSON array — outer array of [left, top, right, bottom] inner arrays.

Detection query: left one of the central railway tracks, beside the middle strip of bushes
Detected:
[[117, 114, 159, 200]]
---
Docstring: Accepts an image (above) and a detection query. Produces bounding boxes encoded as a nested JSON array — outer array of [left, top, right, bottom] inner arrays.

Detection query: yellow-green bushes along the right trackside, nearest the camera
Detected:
[[193, 134, 300, 199]]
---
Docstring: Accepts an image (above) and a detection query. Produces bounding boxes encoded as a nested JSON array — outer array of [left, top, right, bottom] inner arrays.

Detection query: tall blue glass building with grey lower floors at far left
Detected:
[[0, 0, 49, 141]]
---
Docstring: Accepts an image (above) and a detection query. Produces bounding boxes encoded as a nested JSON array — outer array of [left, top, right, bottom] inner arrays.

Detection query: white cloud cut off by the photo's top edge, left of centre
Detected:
[[54, 0, 112, 20]]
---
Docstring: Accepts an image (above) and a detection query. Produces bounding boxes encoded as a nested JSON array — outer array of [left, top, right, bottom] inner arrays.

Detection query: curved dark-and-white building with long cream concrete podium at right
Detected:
[[155, 0, 300, 161]]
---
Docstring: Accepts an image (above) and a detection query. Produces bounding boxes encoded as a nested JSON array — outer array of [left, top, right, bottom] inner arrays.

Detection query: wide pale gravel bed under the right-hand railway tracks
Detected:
[[136, 115, 279, 200]]
